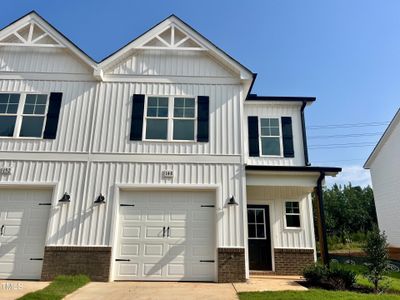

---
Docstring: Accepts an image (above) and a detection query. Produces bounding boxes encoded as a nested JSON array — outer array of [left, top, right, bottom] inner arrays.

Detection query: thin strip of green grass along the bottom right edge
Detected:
[[238, 289, 400, 300]]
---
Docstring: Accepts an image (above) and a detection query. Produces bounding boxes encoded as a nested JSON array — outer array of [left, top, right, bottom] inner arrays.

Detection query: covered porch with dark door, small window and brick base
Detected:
[[246, 166, 340, 275]]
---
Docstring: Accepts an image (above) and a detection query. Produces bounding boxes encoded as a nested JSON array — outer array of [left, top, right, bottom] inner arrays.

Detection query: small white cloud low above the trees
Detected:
[[326, 165, 371, 187]]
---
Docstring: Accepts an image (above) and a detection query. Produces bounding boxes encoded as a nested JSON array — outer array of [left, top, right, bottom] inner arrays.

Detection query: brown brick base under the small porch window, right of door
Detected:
[[274, 248, 314, 275]]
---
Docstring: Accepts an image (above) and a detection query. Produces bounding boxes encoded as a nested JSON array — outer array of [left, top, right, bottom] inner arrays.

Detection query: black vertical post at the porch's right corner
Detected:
[[316, 171, 329, 267]]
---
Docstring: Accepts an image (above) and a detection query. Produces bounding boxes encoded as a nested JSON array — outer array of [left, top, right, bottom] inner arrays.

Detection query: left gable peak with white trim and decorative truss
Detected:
[[0, 10, 97, 69]]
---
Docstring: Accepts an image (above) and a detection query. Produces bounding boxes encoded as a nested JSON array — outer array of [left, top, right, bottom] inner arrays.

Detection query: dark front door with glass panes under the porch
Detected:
[[247, 205, 272, 271]]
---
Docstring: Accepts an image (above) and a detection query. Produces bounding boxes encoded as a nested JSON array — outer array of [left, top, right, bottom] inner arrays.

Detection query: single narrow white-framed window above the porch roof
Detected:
[[260, 118, 282, 156]]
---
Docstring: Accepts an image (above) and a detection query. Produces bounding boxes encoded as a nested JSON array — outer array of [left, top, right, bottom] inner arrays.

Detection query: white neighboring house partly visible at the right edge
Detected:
[[364, 109, 400, 260]]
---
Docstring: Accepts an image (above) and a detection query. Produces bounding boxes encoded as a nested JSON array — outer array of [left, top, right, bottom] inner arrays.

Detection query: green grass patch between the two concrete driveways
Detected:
[[19, 275, 90, 300]]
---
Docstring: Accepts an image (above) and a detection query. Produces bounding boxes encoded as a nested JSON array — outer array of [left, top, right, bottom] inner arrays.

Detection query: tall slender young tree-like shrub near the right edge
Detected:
[[363, 229, 389, 293]]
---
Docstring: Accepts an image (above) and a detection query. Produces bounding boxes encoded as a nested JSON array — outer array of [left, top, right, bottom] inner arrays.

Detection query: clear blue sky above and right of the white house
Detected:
[[0, 0, 400, 185]]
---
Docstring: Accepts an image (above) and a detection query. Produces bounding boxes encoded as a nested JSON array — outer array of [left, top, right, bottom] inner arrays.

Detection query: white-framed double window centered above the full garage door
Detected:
[[143, 96, 197, 141]]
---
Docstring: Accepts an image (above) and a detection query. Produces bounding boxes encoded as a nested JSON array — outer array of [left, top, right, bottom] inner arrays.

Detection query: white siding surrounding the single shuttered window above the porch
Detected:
[[243, 101, 305, 166]]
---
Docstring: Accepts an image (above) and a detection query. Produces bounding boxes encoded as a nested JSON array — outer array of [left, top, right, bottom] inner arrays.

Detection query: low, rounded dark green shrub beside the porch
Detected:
[[303, 264, 356, 290]]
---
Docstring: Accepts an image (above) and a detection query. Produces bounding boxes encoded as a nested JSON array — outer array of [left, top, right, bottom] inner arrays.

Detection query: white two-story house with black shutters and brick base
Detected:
[[0, 12, 340, 282]]
